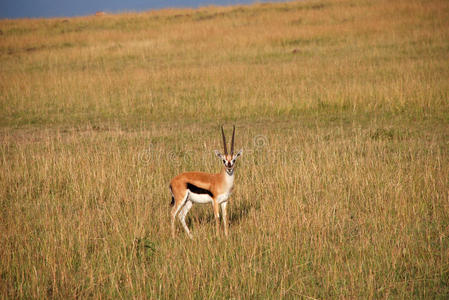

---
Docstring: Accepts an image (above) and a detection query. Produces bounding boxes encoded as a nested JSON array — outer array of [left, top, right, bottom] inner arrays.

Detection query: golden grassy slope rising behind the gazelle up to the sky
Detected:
[[1, 2, 449, 126]]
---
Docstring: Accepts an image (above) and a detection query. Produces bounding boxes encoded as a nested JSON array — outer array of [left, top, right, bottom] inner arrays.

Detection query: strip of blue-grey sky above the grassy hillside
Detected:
[[0, 0, 279, 19]]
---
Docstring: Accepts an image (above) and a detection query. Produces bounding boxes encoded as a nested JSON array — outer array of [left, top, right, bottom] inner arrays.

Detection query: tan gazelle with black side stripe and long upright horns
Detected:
[[170, 126, 243, 238]]
